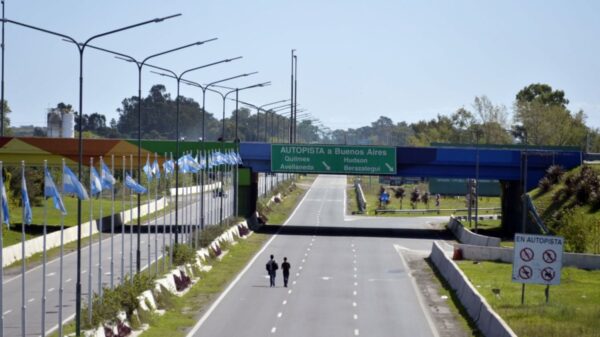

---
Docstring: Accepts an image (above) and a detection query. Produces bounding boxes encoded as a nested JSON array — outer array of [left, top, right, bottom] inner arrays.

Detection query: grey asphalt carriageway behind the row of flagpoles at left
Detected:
[[2, 177, 244, 337]]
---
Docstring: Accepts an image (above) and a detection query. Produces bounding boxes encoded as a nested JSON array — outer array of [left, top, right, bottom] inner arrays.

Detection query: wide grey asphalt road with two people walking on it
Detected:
[[188, 176, 448, 337]]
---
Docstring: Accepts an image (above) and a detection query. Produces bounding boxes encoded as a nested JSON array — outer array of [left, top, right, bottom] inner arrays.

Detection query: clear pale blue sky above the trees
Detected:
[[4, 0, 600, 129]]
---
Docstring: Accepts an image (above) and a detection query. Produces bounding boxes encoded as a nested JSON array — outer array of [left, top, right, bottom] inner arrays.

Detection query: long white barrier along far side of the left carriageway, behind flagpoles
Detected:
[[2, 198, 168, 268]]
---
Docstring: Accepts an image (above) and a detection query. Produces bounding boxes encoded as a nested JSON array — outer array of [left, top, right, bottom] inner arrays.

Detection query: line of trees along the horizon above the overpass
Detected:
[[5, 83, 600, 152]]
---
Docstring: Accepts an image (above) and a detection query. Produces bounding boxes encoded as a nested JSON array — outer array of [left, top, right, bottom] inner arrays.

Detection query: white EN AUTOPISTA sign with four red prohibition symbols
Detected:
[[512, 234, 565, 285]]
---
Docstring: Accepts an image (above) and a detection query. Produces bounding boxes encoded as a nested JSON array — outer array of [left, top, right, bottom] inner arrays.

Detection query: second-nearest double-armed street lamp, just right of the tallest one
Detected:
[[83, 38, 217, 273]]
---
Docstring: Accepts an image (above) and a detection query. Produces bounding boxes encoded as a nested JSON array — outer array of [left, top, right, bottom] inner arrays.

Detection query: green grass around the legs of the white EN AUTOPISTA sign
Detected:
[[458, 261, 600, 337]]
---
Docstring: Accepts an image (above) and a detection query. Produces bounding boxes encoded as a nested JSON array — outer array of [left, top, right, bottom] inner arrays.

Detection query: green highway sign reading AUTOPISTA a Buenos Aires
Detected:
[[271, 144, 396, 175]]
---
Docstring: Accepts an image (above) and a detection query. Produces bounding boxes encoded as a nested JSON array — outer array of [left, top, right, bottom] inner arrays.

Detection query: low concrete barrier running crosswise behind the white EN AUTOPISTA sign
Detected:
[[455, 244, 600, 270]]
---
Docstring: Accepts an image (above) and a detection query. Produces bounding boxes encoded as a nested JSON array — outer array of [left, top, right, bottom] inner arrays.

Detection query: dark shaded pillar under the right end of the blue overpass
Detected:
[[500, 180, 523, 235]]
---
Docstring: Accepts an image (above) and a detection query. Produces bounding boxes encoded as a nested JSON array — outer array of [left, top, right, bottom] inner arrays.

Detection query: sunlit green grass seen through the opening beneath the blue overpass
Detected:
[[348, 176, 500, 216]]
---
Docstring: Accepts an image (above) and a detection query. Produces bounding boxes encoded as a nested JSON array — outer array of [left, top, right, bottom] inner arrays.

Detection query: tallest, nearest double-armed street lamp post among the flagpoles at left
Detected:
[[2, 14, 181, 336]]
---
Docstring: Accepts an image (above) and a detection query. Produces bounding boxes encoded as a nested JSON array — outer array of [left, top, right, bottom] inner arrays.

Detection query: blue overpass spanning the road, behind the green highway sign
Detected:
[[240, 143, 583, 232]]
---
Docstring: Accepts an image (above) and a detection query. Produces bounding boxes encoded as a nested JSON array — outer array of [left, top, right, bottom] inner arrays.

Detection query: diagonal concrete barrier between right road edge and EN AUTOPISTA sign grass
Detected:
[[429, 242, 517, 337]]
